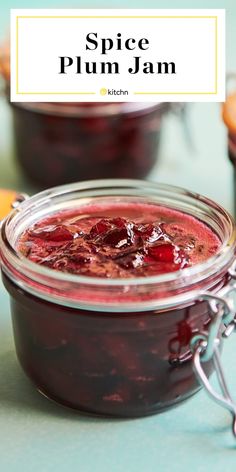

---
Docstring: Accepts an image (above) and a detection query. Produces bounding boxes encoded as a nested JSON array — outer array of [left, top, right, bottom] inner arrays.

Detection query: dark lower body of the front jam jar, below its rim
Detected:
[[3, 276, 218, 417]]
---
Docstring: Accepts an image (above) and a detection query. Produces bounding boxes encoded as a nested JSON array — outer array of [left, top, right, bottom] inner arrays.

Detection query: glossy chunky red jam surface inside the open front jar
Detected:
[[17, 204, 220, 278]]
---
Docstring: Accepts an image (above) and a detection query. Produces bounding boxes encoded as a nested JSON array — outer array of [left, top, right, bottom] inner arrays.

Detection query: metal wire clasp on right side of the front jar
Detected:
[[190, 262, 236, 438]]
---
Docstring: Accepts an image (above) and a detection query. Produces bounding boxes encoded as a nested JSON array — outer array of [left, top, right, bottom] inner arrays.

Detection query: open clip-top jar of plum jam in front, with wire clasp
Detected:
[[0, 179, 236, 436]]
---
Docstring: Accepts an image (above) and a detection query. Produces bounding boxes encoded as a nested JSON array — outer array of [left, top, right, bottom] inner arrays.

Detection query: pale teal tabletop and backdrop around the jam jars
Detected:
[[0, 0, 236, 472]]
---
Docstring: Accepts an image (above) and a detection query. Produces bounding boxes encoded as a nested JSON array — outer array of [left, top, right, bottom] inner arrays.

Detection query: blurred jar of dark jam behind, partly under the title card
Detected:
[[11, 103, 168, 188]]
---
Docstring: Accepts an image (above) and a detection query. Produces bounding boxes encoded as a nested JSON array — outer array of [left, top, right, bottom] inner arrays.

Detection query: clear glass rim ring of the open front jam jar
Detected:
[[0, 179, 236, 308]]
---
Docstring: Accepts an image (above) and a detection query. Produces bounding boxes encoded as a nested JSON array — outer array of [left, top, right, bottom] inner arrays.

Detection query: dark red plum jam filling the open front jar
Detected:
[[3, 203, 221, 417]]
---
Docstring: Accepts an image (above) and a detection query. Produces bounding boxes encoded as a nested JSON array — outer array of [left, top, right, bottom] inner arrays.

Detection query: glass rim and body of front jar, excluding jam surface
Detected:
[[0, 179, 236, 417]]
